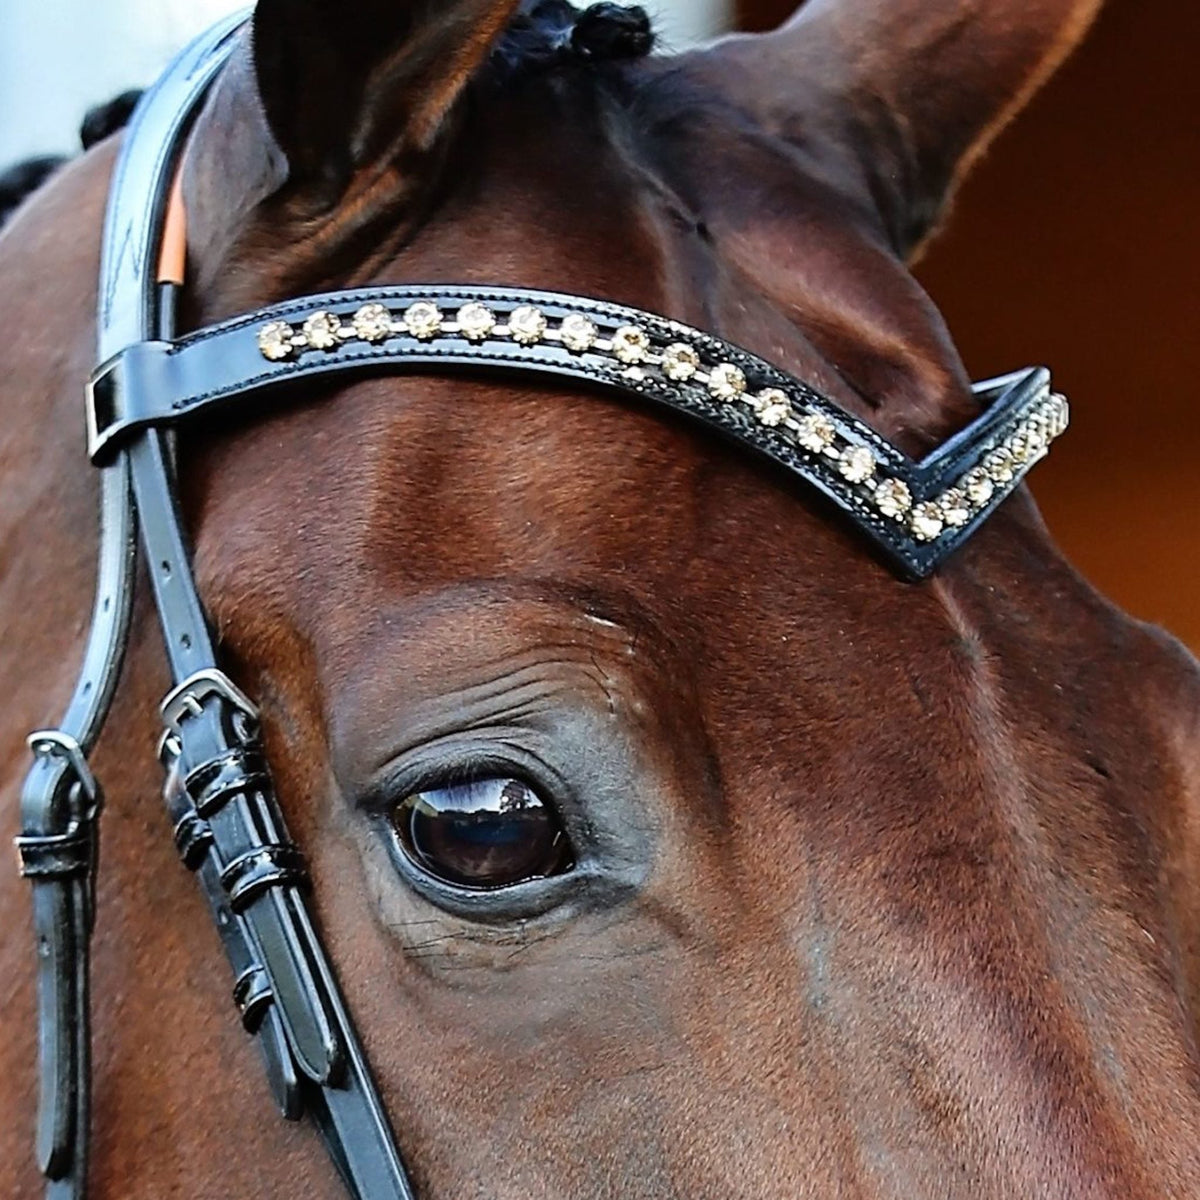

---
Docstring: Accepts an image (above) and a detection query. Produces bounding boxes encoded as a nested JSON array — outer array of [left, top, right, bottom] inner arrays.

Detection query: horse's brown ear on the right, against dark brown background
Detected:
[[715, 0, 1102, 254]]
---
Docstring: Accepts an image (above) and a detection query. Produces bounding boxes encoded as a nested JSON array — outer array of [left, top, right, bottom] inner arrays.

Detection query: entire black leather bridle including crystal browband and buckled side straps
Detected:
[[17, 17, 1068, 1200]]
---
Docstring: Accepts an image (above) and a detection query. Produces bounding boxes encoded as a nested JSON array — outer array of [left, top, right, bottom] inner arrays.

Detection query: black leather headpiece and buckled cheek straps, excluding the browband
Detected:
[[18, 19, 413, 1200]]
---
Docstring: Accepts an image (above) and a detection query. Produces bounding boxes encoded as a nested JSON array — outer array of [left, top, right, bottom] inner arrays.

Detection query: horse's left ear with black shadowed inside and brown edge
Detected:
[[253, 0, 520, 185]]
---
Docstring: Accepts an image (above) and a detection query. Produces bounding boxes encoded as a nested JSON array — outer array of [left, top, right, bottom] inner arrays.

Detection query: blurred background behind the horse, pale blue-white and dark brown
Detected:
[[0, 0, 1200, 650]]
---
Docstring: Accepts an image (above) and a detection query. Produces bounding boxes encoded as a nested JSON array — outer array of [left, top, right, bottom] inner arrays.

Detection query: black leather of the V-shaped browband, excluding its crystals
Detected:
[[88, 286, 1062, 578]]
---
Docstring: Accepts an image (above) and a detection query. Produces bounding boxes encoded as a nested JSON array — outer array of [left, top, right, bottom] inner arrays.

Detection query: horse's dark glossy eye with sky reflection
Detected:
[[391, 779, 574, 889]]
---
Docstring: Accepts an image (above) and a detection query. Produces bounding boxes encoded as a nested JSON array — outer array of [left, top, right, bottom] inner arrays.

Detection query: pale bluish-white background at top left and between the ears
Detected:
[[0, 0, 730, 169]]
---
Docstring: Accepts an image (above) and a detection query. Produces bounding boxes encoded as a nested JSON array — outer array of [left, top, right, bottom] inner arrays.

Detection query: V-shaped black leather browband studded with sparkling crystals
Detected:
[[89, 286, 1069, 578]]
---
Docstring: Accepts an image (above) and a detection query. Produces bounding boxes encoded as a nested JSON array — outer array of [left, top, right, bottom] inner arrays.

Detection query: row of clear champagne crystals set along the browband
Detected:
[[258, 300, 1069, 541]]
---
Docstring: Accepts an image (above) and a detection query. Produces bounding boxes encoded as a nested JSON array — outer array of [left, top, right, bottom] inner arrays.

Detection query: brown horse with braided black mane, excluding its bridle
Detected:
[[0, 0, 1200, 1200]]
